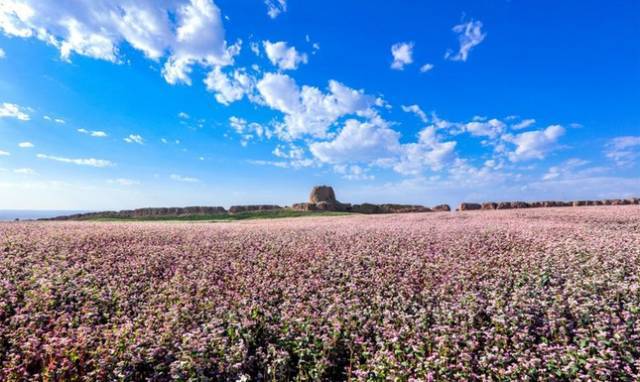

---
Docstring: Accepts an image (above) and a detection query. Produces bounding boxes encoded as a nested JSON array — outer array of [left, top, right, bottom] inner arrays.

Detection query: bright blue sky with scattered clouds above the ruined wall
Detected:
[[0, 0, 640, 209]]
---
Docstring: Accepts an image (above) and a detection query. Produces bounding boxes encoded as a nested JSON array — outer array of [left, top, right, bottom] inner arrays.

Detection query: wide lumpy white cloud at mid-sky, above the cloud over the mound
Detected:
[[257, 73, 379, 139]]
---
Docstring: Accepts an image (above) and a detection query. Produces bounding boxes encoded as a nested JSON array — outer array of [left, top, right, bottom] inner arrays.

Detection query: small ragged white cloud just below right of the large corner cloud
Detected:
[[204, 66, 255, 105]]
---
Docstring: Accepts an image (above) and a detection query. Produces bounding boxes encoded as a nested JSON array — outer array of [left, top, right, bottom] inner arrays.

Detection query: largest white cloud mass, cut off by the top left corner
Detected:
[[0, 0, 239, 84]]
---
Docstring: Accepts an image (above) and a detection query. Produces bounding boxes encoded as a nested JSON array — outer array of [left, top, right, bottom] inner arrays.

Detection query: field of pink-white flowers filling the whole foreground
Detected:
[[0, 206, 640, 381]]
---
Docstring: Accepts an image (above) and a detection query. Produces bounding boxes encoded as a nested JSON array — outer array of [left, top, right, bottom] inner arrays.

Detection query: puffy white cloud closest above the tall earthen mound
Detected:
[[309, 118, 400, 164]]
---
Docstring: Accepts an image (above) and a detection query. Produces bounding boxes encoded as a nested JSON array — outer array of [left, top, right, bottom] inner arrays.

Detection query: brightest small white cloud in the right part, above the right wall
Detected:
[[503, 125, 565, 162]]
